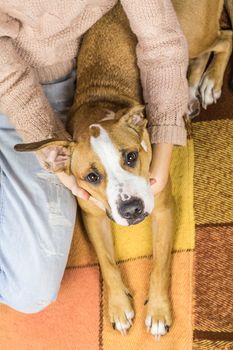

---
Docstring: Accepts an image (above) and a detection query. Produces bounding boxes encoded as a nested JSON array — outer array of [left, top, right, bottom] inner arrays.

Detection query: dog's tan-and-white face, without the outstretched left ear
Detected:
[[76, 106, 154, 226]]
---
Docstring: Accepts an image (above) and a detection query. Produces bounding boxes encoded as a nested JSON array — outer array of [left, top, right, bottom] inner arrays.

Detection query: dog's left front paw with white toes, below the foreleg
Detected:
[[108, 290, 134, 335]]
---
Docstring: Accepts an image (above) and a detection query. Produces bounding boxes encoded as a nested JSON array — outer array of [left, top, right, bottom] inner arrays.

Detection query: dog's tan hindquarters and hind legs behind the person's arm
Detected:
[[180, 0, 233, 118]]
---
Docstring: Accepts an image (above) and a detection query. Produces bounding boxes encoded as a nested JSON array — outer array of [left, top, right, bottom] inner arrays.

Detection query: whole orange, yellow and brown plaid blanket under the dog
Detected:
[[0, 65, 233, 350]]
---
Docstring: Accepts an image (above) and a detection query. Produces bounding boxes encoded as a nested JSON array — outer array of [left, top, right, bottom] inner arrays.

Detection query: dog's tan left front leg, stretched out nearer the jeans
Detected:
[[83, 213, 134, 334]]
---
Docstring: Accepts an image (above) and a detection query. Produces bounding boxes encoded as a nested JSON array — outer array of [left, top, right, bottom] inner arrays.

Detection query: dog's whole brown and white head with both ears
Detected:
[[15, 106, 154, 226]]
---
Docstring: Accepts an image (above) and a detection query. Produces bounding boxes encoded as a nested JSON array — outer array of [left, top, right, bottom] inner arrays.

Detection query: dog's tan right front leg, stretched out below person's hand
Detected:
[[145, 181, 174, 339]]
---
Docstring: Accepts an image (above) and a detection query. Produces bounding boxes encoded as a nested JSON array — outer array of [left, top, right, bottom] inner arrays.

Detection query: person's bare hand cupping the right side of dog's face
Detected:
[[150, 143, 173, 194]]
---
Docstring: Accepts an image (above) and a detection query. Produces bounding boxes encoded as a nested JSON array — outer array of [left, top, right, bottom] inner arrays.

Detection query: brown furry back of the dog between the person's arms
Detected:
[[73, 3, 142, 110]]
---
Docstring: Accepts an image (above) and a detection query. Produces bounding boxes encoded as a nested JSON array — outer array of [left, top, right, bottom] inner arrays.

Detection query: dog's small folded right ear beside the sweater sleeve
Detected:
[[119, 105, 147, 133]]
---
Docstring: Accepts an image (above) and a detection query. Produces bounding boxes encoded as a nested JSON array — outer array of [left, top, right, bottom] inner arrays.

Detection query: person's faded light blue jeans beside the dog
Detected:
[[0, 72, 77, 313]]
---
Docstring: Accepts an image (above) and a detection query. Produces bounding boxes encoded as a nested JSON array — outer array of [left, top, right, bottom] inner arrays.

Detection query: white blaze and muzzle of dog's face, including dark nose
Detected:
[[91, 126, 154, 226]]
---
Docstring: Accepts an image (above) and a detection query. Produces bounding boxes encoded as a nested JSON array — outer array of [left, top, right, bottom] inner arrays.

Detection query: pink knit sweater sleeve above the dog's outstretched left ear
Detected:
[[0, 10, 69, 142]]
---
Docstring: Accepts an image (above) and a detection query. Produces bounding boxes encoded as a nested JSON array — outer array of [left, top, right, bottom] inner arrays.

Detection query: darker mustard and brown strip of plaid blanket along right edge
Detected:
[[193, 57, 233, 350]]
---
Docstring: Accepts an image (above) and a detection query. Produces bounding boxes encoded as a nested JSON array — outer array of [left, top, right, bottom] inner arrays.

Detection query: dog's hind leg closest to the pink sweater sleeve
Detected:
[[188, 53, 210, 118]]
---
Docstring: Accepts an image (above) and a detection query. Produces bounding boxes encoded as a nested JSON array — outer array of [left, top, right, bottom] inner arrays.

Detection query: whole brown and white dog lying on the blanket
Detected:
[[16, 0, 231, 337]]
